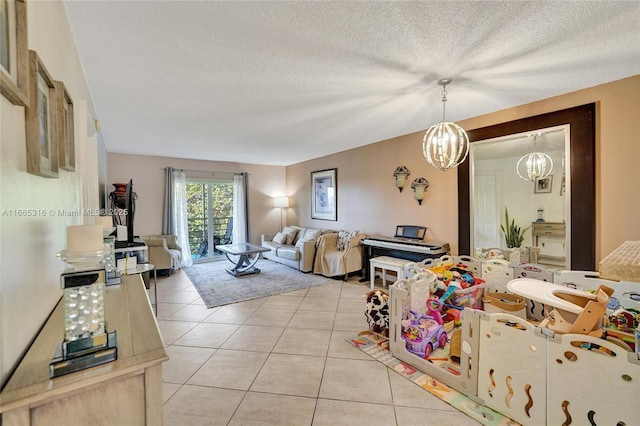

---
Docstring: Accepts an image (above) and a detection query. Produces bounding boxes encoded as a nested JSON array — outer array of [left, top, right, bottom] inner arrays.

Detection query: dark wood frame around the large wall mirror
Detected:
[[458, 103, 596, 271]]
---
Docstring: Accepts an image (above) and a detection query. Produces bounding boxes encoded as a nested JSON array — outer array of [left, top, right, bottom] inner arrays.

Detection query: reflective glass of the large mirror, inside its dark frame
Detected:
[[469, 125, 571, 269]]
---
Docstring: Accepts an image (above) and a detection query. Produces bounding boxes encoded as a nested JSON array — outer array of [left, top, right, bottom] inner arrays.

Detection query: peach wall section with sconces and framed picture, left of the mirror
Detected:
[[287, 132, 458, 252]]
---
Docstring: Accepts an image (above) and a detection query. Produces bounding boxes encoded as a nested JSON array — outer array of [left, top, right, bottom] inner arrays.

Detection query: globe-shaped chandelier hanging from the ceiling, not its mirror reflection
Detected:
[[422, 78, 469, 171]]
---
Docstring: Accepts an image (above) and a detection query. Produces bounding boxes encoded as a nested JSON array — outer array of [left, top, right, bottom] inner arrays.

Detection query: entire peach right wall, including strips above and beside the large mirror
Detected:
[[287, 76, 640, 263]]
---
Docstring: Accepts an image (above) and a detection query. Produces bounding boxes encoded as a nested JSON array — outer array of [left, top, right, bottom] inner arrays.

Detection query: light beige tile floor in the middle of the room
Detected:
[[158, 260, 478, 426]]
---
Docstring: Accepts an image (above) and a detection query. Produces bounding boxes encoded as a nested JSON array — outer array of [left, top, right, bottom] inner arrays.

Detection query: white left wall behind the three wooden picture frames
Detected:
[[0, 1, 97, 384]]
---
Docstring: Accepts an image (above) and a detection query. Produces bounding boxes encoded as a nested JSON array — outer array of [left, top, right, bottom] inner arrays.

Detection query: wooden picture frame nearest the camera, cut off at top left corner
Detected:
[[0, 0, 29, 107]]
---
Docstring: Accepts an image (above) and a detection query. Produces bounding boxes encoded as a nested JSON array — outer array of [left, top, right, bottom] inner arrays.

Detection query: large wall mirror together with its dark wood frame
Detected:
[[458, 104, 595, 271]]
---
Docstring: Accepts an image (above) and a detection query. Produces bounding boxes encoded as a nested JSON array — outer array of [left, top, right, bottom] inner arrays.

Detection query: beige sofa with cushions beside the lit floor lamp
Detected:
[[261, 226, 331, 272]]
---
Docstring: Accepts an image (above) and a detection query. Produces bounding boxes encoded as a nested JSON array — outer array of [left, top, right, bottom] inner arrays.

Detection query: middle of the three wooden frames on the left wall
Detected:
[[25, 50, 59, 178]]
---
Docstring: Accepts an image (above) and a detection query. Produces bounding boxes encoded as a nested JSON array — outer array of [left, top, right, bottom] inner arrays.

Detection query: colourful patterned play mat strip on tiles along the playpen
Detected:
[[347, 331, 520, 426]]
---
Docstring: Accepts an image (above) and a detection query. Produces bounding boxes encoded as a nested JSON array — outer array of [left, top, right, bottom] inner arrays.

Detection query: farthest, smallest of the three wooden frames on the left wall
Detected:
[[54, 81, 76, 172]]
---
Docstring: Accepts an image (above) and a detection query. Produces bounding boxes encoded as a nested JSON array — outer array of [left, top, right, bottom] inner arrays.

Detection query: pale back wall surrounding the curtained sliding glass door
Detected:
[[106, 153, 285, 243]]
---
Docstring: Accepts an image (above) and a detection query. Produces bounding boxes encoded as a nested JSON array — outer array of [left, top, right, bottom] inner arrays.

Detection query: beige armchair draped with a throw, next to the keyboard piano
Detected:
[[313, 232, 366, 280]]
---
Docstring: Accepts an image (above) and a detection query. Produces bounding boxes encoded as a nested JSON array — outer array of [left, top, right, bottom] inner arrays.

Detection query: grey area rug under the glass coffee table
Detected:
[[184, 259, 334, 308]]
